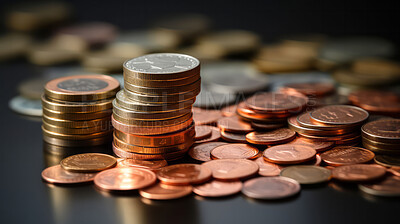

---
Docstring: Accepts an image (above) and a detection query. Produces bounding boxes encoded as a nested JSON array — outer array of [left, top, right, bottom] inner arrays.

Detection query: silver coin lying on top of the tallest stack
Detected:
[[124, 53, 200, 74]]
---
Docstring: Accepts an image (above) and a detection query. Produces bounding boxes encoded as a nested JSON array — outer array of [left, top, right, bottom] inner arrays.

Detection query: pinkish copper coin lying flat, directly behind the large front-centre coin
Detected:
[[210, 143, 258, 159]]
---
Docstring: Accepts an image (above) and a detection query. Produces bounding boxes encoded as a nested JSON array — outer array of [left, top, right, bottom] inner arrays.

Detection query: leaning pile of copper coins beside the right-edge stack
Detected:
[[288, 105, 369, 145]]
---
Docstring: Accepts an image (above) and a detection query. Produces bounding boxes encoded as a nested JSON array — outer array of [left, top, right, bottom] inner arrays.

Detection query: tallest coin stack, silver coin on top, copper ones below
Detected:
[[112, 53, 201, 160]]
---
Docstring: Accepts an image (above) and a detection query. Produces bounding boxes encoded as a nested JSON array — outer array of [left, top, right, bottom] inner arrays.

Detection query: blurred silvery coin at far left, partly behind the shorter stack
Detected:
[[8, 96, 42, 116]]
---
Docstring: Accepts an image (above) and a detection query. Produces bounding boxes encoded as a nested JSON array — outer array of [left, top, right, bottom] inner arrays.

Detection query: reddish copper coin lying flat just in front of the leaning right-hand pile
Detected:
[[321, 146, 375, 166]]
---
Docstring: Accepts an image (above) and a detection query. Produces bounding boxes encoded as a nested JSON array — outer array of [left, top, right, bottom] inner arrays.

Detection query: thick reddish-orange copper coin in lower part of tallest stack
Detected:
[[114, 124, 195, 147]]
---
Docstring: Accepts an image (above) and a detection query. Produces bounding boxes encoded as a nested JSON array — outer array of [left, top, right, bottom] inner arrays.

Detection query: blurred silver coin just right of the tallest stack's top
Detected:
[[201, 61, 269, 94]]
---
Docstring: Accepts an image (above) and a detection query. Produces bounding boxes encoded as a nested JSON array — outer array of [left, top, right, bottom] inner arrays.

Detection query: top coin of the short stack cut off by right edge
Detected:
[[361, 119, 400, 144]]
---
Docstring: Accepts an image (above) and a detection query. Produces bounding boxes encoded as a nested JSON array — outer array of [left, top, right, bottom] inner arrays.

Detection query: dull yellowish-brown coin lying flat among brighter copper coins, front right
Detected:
[[280, 165, 331, 184]]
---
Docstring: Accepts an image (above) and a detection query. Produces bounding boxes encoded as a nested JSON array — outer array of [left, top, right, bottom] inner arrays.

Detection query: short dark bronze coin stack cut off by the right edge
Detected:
[[361, 119, 400, 155]]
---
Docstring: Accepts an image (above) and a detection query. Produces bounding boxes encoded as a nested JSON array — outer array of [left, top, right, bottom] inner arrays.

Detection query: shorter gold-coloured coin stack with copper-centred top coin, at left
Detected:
[[42, 75, 119, 147]]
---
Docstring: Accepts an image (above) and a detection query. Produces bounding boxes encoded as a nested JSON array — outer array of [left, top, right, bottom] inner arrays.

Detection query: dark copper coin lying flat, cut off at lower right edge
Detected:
[[358, 175, 400, 197]]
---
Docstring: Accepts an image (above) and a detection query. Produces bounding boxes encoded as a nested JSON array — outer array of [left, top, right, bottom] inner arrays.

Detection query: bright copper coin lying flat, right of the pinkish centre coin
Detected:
[[263, 144, 317, 164]]
